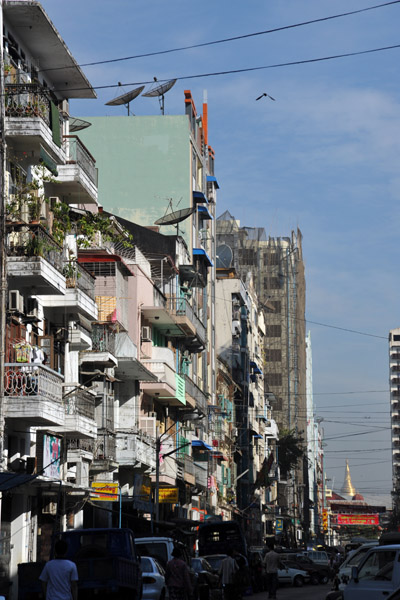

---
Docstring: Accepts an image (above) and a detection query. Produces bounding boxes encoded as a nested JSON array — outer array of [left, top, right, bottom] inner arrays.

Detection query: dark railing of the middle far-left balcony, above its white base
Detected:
[[7, 224, 64, 273]]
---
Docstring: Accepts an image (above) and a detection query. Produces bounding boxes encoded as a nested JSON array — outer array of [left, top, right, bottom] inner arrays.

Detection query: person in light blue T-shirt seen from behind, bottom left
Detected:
[[39, 540, 78, 600]]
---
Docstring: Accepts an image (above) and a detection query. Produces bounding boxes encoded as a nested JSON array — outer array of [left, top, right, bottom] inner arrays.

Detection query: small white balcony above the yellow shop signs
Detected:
[[116, 431, 156, 469]]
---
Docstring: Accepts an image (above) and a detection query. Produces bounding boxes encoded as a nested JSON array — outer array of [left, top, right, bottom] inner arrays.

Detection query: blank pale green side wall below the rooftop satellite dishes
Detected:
[[78, 115, 192, 247]]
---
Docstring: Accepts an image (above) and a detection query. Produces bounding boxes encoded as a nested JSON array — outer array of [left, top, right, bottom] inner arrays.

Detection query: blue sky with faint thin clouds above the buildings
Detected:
[[42, 0, 400, 502]]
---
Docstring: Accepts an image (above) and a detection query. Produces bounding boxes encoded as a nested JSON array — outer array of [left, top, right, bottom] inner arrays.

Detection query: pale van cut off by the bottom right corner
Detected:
[[343, 544, 400, 600]]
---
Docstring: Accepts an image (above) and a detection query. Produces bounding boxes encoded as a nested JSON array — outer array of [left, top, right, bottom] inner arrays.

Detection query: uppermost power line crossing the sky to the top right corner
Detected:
[[39, 0, 400, 73]]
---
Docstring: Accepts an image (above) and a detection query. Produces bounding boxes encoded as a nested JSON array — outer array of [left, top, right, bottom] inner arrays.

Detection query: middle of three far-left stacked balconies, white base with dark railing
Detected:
[[7, 223, 66, 296]]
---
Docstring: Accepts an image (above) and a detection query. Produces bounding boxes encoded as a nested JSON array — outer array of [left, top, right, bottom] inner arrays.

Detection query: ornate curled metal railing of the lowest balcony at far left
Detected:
[[4, 363, 64, 404]]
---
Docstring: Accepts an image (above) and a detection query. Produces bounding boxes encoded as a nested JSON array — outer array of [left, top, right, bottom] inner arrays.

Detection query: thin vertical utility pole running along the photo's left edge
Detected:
[[0, 0, 7, 471]]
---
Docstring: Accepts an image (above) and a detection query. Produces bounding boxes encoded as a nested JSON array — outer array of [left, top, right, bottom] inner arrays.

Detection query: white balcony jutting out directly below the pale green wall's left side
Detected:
[[48, 135, 98, 205]]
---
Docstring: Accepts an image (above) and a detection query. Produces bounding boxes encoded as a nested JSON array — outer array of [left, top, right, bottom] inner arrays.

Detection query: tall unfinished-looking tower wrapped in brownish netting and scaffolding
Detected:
[[216, 211, 307, 542]]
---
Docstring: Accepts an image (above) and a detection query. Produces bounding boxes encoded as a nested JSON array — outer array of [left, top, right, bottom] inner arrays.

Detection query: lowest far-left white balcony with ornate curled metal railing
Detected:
[[4, 363, 65, 427]]
